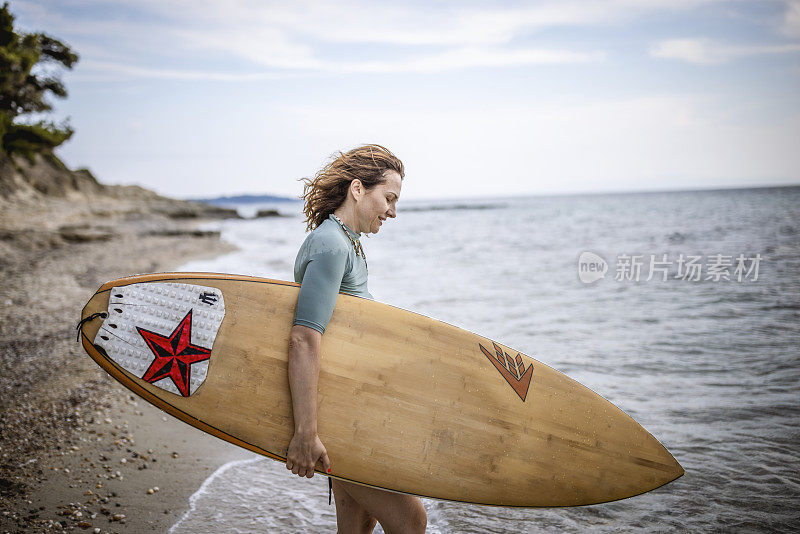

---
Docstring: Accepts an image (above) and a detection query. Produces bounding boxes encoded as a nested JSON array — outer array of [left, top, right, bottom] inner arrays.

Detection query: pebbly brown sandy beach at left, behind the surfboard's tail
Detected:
[[0, 160, 250, 533]]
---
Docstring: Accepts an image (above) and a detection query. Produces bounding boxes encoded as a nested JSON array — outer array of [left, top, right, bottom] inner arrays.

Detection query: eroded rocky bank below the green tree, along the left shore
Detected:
[[0, 149, 241, 258]]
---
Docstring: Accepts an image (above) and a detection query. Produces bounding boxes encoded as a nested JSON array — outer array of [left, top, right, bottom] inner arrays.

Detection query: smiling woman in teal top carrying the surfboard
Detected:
[[286, 145, 427, 534]]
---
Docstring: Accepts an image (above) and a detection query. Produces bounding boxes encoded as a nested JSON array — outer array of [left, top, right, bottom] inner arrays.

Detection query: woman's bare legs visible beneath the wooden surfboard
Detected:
[[333, 479, 428, 534]]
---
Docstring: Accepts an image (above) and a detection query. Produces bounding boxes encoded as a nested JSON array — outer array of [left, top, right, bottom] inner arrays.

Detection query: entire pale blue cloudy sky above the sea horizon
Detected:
[[10, 0, 800, 198]]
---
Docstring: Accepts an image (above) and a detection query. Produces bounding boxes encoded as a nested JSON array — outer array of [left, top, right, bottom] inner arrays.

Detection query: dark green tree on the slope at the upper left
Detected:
[[0, 2, 78, 161]]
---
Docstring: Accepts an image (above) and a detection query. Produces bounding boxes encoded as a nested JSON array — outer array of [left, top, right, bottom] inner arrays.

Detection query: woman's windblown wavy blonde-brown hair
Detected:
[[300, 145, 405, 230]]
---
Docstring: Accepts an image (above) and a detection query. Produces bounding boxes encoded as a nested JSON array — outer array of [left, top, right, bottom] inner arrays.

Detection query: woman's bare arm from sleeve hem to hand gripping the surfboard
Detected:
[[286, 325, 331, 478]]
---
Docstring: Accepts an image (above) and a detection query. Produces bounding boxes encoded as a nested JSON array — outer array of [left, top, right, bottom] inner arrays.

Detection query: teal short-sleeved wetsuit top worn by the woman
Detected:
[[294, 214, 372, 334]]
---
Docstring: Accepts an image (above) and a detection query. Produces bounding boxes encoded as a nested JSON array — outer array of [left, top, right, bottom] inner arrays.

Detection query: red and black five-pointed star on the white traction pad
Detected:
[[136, 310, 211, 397]]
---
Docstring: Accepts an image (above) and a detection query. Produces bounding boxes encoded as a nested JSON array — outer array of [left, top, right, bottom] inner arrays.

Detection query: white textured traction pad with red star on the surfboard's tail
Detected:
[[94, 282, 225, 397]]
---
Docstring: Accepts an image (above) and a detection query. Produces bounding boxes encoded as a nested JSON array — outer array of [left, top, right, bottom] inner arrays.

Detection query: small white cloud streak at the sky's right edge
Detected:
[[650, 37, 800, 65]]
